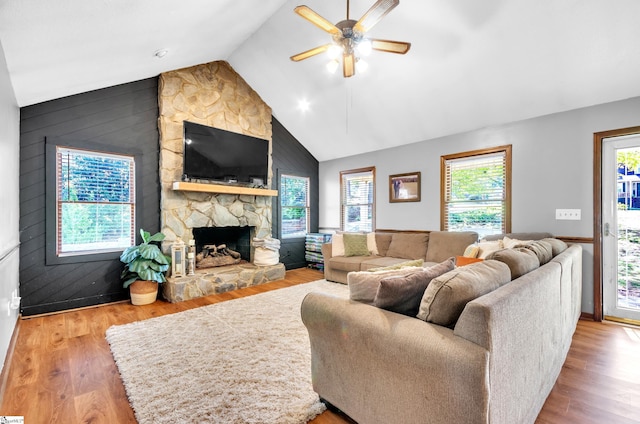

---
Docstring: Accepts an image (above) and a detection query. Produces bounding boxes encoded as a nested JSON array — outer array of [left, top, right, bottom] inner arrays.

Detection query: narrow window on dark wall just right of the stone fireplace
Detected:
[[280, 174, 310, 238]]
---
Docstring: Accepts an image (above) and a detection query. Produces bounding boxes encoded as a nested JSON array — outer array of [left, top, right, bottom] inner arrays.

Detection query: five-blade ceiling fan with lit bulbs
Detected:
[[291, 0, 411, 78]]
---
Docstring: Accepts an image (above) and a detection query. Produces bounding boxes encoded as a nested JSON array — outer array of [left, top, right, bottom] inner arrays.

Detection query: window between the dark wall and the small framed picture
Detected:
[[340, 167, 375, 232]]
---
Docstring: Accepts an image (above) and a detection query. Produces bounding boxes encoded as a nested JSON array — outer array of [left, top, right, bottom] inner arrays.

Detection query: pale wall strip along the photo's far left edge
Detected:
[[0, 41, 20, 374]]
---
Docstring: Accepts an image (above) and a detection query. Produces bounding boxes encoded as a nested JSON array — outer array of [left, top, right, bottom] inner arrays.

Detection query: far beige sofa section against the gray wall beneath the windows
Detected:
[[322, 231, 478, 284]]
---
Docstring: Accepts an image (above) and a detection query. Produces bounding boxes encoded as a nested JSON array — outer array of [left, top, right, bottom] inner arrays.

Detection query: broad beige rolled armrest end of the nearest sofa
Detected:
[[301, 293, 489, 424]]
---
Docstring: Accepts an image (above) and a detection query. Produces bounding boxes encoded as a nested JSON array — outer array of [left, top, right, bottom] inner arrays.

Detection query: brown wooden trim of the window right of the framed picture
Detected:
[[440, 144, 512, 233]]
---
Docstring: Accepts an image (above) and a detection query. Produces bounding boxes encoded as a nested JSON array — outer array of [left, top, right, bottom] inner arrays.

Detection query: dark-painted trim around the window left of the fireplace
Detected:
[[45, 137, 144, 265]]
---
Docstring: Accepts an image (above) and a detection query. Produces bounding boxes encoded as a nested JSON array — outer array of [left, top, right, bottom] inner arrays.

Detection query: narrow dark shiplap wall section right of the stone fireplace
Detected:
[[271, 117, 319, 269]]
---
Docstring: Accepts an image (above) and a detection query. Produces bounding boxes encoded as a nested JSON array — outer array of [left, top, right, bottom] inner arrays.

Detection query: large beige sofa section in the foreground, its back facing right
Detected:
[[301, 235, 582, 424]]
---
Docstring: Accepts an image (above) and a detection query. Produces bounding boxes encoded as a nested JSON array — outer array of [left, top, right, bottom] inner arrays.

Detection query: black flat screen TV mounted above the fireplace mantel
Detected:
[[182, 121, 269, 186]]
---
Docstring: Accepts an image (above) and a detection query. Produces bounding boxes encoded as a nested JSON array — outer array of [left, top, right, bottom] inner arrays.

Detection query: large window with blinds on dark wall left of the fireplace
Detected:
[[55, 146, 135, 257]]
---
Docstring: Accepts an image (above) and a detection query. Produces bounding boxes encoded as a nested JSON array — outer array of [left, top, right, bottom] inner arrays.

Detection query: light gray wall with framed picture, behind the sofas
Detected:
[[319, 97, 640, 313]]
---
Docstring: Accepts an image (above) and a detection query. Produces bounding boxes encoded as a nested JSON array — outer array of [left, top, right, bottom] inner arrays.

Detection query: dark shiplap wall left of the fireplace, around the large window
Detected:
[[20, 78, 160, 316]]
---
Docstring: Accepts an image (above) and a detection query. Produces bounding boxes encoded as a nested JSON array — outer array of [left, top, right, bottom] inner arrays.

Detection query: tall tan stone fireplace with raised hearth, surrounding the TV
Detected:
[[158, 61, 284, 302]]
